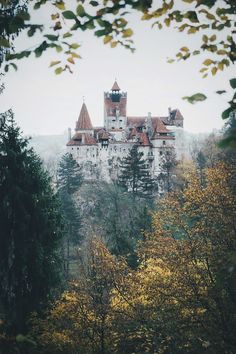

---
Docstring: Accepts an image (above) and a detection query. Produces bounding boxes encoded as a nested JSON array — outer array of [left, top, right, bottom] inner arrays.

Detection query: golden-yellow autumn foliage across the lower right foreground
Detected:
[[31, 163, 236, 354]]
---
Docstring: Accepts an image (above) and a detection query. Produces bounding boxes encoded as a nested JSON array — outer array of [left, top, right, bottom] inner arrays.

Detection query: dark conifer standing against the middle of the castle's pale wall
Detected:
[[118, 145, 154, 197]]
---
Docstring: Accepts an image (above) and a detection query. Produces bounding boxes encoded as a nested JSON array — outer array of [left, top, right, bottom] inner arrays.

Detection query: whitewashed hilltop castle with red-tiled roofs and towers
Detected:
[[67, 81, 183, 181]]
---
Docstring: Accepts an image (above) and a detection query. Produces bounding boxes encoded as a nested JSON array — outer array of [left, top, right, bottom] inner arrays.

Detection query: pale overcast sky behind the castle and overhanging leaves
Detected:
[[0, 2, 234, 135]]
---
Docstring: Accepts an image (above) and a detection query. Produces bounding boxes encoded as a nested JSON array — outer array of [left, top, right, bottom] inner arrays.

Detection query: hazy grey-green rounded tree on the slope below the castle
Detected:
[[79, 182, 152, 267]]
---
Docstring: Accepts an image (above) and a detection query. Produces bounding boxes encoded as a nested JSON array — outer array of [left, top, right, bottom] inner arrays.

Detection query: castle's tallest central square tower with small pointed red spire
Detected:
[[104, 81, 127, 132]]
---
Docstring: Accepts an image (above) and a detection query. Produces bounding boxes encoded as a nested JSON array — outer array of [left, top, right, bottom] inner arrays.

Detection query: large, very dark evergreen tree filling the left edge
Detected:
[[0, 111, 61, 334]]
